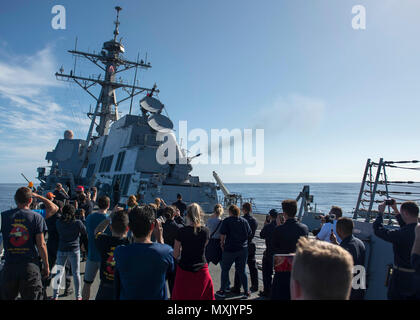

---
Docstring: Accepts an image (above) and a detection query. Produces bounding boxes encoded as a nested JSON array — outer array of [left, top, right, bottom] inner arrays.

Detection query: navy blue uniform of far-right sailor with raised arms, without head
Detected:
[[373, 214, 419, 300]]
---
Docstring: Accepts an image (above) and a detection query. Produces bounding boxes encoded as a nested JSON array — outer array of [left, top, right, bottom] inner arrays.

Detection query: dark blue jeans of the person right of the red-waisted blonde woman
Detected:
[[220, 247, 248, 292]]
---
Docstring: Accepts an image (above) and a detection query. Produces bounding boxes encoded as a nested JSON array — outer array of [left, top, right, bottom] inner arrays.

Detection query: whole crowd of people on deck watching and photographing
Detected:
[[0, 183, 420, 300]]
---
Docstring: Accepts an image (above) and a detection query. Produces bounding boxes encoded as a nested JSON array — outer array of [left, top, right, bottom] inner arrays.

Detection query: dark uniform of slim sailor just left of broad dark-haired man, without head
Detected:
[[260, 221, 277, 294]]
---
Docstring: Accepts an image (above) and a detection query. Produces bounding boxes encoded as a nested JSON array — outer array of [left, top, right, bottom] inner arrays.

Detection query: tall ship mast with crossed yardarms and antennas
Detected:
[[55, 7, 159, 159]]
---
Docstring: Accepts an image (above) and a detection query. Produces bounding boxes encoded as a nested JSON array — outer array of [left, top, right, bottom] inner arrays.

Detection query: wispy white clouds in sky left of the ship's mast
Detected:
[[0, 47, 89, 182]]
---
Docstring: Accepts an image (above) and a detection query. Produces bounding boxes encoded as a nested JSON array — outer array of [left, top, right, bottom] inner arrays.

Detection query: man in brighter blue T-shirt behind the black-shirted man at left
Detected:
[[82, 196, 110, 300]]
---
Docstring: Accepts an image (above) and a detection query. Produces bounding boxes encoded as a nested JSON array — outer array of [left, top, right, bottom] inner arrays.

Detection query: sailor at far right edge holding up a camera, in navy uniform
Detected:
[[373, 199, 420, 300]]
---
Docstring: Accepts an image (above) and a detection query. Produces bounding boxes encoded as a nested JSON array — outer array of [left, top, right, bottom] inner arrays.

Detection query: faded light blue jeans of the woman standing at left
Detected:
[[53, 250, 82, 299]]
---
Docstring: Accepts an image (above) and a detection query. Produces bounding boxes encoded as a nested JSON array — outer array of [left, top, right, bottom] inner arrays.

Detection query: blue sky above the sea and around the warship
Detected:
[[0, 0, 420, 182]]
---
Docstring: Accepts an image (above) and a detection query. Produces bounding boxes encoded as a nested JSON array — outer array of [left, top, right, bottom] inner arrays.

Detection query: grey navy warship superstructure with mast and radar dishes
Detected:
[[37, 7, 218, 212]]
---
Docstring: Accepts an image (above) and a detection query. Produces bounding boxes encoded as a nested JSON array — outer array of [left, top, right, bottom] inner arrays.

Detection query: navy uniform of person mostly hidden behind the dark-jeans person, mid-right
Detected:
[[234, 213, 258, 291]]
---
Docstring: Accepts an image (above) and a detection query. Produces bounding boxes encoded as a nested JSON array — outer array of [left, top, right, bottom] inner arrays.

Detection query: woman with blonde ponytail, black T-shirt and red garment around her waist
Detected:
[[172, 203, 214, 300]]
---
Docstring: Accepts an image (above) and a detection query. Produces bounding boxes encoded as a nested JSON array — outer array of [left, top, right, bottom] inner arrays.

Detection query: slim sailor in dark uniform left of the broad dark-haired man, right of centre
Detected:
[[260, 209, 278, 297]]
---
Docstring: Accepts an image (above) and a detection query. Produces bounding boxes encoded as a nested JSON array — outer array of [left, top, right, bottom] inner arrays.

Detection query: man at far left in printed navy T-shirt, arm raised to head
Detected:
[[1, 187, 58, 300]]
